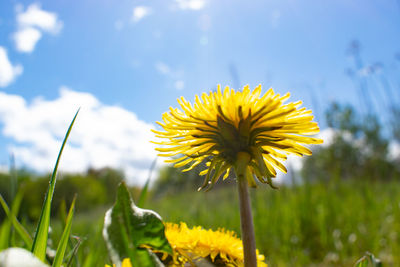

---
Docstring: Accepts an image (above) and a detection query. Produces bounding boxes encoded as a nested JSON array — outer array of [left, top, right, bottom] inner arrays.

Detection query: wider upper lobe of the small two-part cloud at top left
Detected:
[[17, 4, 63, 34]]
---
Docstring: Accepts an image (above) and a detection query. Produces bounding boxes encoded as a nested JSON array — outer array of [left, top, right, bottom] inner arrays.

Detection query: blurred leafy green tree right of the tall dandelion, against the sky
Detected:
[[302, 104, 400, 181]]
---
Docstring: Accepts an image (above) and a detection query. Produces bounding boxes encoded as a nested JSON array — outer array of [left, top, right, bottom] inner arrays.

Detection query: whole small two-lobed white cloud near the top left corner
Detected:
[[13, 4, 63, 53]]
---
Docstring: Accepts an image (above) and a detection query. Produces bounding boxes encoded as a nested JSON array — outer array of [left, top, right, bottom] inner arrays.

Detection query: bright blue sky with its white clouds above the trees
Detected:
[[0, 0, 400, 184]]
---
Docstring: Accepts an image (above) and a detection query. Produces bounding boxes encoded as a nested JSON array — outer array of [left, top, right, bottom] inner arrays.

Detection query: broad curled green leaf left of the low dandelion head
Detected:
[[103, 183, 172, 267]]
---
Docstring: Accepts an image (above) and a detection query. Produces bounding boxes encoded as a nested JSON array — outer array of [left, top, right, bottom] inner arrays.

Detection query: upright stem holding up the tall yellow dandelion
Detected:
[[235, 152, 257, 267]]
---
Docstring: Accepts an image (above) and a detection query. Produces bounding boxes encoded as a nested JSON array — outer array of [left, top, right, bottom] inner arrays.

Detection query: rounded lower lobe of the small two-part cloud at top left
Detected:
[[13, 27, 42, 53]]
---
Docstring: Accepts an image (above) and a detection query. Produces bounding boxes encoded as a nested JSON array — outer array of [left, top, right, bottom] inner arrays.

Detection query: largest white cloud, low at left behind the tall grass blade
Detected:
[[0, 87, 157, 184]]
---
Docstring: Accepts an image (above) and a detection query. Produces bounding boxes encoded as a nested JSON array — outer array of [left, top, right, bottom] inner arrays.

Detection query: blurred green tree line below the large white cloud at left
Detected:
[[0, 168, 143, 221]]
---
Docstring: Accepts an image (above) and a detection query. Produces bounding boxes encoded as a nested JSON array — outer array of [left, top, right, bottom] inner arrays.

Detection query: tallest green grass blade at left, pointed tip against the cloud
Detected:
[[31, 109, 79, 262]]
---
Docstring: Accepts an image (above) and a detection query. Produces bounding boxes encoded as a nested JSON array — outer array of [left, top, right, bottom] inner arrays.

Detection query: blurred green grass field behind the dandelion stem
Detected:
[[44, 180, 400, 266]]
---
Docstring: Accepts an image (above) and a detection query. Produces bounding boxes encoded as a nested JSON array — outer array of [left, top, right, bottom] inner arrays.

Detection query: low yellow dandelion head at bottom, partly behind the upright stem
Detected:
[[165, 222, 267, 267]]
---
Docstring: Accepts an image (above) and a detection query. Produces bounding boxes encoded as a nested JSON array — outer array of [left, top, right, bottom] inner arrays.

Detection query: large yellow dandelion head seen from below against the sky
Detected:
[[153, 85, 322, 188]]
